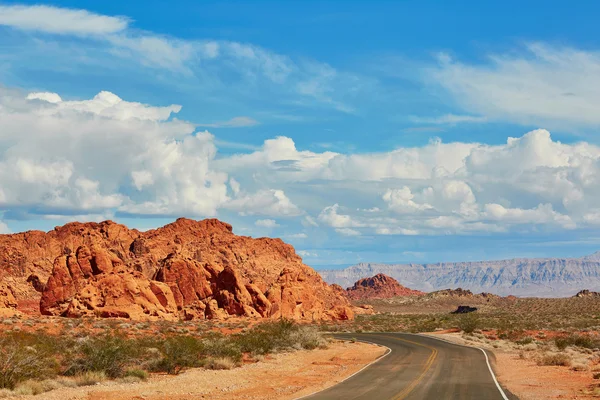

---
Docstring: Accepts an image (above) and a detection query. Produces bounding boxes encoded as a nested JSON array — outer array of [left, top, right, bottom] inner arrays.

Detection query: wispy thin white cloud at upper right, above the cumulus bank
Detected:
[[429, 43, 600, 129]]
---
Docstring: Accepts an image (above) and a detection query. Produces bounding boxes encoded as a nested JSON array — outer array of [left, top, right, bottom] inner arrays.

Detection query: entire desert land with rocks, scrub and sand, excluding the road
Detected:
[[0, 218, 600, 399]]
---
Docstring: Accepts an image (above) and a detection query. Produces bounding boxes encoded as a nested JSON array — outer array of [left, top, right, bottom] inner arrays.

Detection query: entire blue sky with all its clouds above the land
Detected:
[[0, 1, 600, 266]]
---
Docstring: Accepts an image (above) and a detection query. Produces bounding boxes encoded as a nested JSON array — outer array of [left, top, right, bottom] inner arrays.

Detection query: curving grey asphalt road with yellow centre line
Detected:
[[304, 333, 517, 400]]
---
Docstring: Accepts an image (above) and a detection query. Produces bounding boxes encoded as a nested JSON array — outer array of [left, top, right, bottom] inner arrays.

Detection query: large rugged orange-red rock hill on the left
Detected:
[[0, 218, 353, 320]]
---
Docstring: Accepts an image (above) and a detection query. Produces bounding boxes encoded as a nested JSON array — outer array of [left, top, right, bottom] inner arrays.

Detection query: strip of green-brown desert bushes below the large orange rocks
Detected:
[[0, 319, 326, 394]]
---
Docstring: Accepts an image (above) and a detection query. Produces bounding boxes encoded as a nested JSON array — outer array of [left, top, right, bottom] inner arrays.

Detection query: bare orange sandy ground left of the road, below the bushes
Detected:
[[8, 342, 386, 400]]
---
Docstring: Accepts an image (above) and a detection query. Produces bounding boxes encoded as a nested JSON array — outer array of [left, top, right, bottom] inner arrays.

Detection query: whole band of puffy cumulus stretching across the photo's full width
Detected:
[[0, 89, 600, 238]]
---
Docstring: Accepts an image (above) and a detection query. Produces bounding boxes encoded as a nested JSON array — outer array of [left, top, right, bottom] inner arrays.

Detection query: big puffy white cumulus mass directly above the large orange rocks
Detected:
[[0, 88, 290, 220]]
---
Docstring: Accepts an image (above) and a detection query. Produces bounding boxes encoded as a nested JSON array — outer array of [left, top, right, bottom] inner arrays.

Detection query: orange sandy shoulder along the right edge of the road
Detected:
[[430, 332, 598, 400]]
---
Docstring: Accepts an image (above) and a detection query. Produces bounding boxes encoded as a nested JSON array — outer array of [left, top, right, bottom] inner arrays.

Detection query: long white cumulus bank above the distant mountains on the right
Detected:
[[218, 129, 600, 235]]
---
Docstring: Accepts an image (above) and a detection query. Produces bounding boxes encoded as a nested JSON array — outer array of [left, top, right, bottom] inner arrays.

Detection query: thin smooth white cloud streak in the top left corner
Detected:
[[0, 5, 128, 35]]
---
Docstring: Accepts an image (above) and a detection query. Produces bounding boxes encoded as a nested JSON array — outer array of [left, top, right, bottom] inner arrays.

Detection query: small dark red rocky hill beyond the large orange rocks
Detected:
[[346, 274, 425, 300]]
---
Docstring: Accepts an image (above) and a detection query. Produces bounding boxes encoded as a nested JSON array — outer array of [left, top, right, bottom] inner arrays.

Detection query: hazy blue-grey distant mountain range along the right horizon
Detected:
[[319, 251, 600, 297]]
